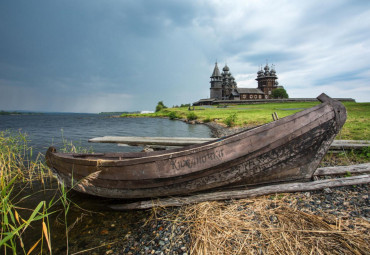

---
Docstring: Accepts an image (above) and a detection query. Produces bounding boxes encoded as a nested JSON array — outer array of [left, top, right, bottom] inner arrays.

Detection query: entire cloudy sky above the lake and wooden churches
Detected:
[[0, 0, 370, 113]]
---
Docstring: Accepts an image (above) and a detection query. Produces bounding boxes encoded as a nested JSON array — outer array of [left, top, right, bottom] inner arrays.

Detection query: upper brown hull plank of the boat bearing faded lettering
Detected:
[[47, 101, 333, 180]]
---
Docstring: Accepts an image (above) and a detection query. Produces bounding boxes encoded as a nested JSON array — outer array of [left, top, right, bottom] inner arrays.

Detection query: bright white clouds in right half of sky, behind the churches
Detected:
[[191, 1, 370, 101]]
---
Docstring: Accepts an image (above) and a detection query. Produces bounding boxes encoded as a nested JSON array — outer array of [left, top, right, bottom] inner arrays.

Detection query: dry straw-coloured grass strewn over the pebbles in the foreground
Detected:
[[174, 195, 370, 255]]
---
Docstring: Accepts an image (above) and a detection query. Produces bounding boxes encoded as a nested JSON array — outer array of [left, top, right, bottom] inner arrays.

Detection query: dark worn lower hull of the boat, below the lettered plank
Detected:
[[51, 118, 338, 198]]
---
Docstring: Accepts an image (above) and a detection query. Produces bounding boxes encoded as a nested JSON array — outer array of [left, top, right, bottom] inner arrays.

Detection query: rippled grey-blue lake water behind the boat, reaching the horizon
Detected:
[[0, 113, 211, 154]]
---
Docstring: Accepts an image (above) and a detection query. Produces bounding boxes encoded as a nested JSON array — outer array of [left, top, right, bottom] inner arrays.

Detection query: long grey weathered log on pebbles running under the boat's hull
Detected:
[[110, 174, 370, 210]]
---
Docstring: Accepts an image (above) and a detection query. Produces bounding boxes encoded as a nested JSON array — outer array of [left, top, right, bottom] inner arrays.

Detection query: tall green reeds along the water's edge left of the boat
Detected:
[[0, 131, 81, 254]]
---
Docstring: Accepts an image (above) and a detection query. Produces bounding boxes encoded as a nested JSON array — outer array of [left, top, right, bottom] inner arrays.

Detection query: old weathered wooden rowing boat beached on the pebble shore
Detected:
[[46, 94, 347, 199]]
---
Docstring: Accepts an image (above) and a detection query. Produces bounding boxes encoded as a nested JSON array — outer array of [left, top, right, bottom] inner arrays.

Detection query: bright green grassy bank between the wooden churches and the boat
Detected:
[[121, 102, 370, 140]]
